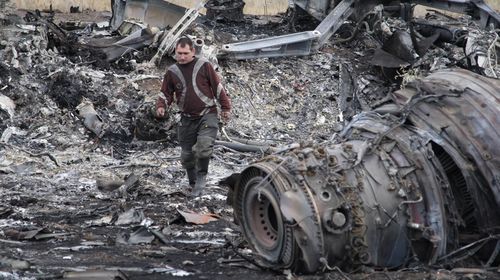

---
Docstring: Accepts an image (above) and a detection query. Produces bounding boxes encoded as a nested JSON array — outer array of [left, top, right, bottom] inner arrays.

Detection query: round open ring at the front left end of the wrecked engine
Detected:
[[235, 165, 297, 268]]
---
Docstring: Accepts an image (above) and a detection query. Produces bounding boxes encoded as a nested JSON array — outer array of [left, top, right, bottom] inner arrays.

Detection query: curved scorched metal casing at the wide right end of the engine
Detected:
[[394, 69, 500, 229]]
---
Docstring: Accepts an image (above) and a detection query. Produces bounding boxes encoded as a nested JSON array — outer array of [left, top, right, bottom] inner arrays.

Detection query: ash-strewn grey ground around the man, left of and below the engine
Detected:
[[0, 2, 500, 280]]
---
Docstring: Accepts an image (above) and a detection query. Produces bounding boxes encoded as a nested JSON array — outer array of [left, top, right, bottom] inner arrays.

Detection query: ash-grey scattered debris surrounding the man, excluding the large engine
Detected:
[[0, 0, 500, 280]]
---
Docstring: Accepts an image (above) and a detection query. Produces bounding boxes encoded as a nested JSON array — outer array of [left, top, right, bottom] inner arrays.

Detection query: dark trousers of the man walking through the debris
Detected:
[[177, 113, 219, 185]]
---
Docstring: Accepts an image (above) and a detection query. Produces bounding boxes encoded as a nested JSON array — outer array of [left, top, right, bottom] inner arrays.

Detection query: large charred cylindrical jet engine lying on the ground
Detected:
[[225, 70, 500, 273]]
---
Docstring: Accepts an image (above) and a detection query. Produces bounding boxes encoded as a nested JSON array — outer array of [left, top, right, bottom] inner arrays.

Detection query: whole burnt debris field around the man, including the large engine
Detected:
[[0, 0, 500, 280]]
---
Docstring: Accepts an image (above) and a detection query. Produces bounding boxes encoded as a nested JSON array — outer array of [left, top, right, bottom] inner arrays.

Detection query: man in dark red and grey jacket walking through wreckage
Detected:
[[156, 37, 231, 197]]
